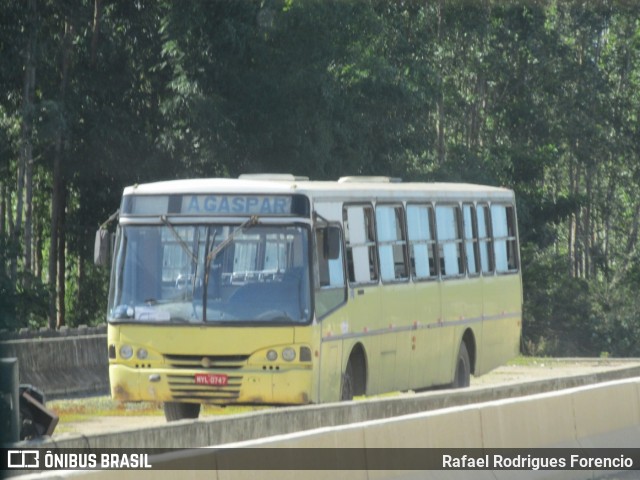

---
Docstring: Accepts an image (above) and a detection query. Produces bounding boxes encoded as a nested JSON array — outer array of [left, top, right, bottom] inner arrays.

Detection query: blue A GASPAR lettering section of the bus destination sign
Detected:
[[181, 195, 291, 215]]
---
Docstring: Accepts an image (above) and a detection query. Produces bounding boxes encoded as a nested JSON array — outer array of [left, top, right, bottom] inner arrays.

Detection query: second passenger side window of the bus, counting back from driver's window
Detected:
[[376, 205, 409, 282]]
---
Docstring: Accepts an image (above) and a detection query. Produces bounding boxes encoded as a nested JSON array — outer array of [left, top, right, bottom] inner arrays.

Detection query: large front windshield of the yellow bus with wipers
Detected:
[[108, 223, 311, 324]]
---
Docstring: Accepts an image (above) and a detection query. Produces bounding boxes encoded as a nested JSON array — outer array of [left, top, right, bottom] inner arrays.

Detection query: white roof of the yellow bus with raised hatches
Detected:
[[124, 174, 513, 201]]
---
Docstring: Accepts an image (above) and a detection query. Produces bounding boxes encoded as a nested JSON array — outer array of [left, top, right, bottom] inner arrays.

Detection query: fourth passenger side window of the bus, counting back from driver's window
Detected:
[[436, 205, 464, 277]]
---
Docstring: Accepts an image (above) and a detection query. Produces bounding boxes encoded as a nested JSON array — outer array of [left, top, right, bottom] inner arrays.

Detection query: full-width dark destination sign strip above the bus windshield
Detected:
[[120, 194, 309, 217]]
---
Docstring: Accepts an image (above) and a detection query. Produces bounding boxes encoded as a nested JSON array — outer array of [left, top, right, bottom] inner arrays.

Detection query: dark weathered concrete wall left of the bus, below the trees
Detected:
[[0, 334, 109, 400]]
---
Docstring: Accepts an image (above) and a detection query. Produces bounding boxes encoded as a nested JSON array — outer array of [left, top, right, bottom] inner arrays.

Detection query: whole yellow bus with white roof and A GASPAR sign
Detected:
[[96, 174, 522, 421]]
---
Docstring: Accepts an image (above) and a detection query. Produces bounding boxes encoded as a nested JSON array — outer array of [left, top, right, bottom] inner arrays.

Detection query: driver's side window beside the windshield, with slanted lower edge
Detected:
[[314, 226, 347, 318]]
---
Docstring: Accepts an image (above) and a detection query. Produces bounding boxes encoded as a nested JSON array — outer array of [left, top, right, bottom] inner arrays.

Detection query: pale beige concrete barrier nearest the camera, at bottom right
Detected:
[[12, 378, 640, 480]]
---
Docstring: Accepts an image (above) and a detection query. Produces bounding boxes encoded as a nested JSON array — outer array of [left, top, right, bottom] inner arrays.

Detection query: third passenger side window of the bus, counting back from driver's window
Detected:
[[407, 205, 438, 280]]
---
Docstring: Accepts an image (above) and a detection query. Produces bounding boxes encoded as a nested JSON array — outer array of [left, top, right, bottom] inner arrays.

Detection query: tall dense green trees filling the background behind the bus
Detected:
[[0, 0, 640, 355]]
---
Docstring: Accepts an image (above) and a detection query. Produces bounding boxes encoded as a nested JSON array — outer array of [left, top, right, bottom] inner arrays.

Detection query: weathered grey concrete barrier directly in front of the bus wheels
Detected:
[[20, 365, 640, 448]]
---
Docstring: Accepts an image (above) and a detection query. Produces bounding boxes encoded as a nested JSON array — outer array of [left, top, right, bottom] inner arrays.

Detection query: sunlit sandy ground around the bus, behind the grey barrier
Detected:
[[48, 359, 640, 439]]
